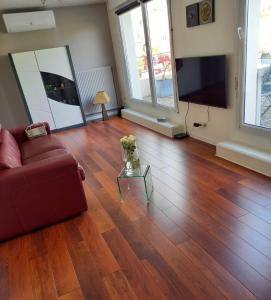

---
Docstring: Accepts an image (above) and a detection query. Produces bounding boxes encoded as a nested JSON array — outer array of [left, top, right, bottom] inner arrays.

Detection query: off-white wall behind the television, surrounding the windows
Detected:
[[108, 0, 271, 147]]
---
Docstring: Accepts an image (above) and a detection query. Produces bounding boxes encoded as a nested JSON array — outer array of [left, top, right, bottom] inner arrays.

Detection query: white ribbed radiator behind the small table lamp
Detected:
[[76, 66, 118, 116]]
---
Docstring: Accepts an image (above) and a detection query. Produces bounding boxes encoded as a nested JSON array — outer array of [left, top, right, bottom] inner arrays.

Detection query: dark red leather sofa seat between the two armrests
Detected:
[[20, 134, 66, 161]]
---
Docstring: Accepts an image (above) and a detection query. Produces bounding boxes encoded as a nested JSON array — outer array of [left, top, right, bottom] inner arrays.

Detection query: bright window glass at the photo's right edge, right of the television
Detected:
[[243, 0, 271, 129]]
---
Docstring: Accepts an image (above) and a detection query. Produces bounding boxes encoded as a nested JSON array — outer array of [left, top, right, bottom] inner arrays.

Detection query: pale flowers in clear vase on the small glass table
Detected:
[[120, 135, 140, 170]]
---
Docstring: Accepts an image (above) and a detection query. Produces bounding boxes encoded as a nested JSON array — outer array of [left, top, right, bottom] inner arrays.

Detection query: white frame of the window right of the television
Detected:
[[240, 0, 271, 134]]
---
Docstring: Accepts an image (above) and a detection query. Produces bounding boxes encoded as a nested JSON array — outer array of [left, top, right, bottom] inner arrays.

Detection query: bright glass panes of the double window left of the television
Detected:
[[117, 0, 175, 108]]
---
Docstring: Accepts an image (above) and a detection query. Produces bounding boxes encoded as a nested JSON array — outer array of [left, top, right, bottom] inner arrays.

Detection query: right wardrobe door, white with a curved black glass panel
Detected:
[[35, 47, 84, 128]]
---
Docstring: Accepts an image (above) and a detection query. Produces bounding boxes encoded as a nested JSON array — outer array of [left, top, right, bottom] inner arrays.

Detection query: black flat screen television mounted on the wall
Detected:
[[176, 55, 227, 108]]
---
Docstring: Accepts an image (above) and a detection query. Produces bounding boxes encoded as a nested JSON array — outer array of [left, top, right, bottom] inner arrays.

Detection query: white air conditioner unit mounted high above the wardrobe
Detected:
[[3, 10, 56, 33]]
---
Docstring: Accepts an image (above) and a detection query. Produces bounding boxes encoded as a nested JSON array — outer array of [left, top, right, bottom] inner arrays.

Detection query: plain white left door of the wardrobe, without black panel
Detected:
[[11, 51, 56, 129]]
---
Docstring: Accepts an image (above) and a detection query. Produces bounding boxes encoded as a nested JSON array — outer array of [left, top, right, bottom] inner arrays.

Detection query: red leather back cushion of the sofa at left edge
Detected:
[[0, 129, 22, 170]]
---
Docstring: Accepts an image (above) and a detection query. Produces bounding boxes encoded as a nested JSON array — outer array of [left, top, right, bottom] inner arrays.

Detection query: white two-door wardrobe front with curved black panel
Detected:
[[10, 47, 85, 130]]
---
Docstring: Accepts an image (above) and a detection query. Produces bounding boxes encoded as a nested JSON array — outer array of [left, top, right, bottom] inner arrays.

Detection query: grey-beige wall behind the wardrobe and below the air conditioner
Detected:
[[0, 4, 115, 127]]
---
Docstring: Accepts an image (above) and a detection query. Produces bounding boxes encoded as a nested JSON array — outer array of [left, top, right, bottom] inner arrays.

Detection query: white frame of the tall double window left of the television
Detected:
[[117, 0, 179, 113]]
